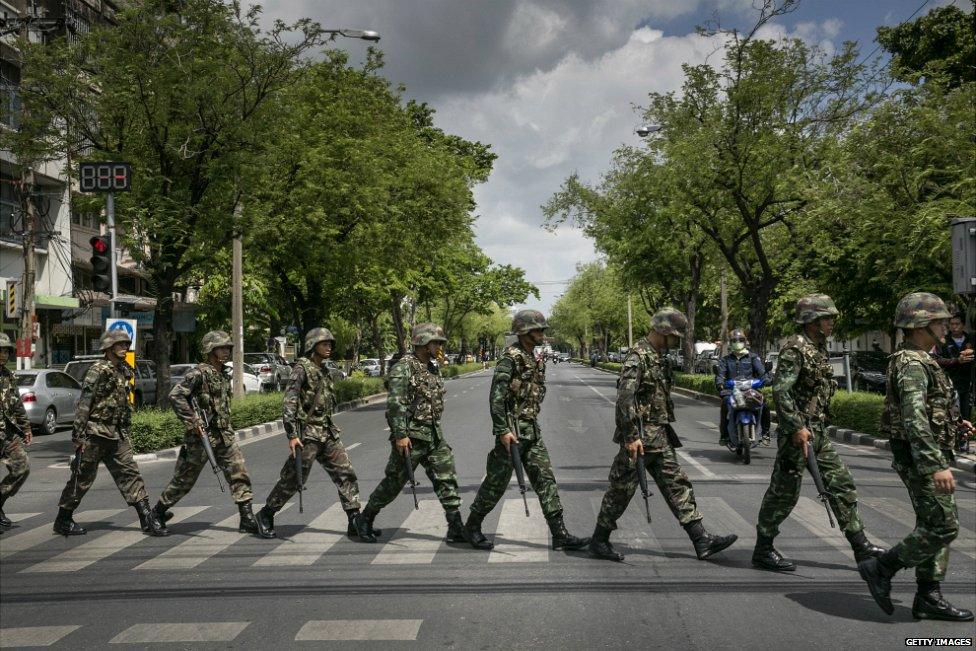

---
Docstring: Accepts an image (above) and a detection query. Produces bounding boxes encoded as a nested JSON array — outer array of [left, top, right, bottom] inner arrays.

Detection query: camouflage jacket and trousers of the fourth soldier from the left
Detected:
[[265, 354, 359, 513]]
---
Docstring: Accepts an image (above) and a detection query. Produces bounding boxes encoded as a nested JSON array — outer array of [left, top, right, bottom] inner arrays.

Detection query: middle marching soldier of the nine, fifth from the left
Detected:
[[360, 323, 466, 542]]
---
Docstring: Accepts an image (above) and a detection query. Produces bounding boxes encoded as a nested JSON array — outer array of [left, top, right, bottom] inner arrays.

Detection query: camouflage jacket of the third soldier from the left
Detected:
[[169, 362, 234, 439]]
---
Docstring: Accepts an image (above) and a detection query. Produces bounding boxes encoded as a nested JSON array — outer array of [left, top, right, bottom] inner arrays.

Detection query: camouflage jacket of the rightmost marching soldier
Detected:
[[881, 345, 959, 475]]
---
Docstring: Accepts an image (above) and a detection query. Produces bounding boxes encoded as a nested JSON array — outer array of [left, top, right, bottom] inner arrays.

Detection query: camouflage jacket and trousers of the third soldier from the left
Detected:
[[159, 362, 251, 507]]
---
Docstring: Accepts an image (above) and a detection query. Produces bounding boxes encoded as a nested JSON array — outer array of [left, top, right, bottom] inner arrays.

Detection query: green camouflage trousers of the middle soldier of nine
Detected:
[[366, 436, 461, 513]]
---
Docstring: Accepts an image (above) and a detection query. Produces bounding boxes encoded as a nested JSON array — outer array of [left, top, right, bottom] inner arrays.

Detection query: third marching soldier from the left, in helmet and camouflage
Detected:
[[154, 330, 272, 538]]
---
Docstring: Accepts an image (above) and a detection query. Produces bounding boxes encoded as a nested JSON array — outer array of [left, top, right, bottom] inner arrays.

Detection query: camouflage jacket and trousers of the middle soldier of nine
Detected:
[[366, 353, 461, 516]]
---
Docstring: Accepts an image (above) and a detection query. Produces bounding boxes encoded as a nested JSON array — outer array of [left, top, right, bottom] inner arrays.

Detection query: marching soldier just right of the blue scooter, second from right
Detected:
[[752, 294, 884, 572]]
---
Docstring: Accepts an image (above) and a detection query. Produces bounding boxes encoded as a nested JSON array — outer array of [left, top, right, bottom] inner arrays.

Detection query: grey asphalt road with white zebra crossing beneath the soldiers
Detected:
[[0, 364, 976, 649]]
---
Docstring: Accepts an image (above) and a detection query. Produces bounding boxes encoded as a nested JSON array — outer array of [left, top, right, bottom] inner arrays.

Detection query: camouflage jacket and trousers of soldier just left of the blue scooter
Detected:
[[597, 340, 702, 531]]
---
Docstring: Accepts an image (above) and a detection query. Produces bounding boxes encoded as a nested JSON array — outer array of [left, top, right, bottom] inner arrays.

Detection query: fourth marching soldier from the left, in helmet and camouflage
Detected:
[[258, 328, 373, 540]]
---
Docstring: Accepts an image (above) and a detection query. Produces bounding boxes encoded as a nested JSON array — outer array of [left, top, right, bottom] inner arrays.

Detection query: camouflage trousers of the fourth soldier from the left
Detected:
[[267, 438, 359, 513]]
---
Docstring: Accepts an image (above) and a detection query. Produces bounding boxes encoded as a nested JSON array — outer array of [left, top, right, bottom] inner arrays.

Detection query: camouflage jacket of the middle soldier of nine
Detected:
[[386, 353, 445, 441]]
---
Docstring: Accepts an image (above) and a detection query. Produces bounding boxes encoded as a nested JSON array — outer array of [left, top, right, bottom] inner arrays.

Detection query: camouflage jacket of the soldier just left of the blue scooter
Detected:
[[613, 339, 674, 450]]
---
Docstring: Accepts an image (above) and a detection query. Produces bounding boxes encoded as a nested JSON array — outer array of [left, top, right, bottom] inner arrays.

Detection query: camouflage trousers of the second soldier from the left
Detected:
[[58, 436, 149, 511]]
